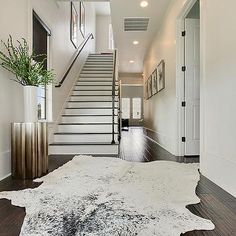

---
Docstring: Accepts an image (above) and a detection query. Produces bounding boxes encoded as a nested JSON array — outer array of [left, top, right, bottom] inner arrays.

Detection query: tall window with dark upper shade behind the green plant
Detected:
[[33, 11, 51, 120]]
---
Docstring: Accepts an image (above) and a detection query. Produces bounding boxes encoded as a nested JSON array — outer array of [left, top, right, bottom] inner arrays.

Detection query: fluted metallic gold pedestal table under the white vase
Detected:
[[11, 122, 48, 179]]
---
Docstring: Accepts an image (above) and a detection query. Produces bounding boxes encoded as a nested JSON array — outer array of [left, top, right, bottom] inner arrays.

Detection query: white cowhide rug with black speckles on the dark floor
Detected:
[[0, 156, 214, 236]]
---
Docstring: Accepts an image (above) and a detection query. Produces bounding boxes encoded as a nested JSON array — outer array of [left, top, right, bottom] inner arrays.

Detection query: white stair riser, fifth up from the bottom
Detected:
[[65, 109, 117, 115]]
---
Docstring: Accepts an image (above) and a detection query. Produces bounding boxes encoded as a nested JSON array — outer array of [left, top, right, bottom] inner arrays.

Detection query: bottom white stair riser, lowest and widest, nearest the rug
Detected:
[[49, 145, 118, 155]]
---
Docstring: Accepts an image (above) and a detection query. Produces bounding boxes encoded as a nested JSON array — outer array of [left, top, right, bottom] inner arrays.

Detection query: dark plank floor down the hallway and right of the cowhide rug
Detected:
[[120, 127, 236, 236]]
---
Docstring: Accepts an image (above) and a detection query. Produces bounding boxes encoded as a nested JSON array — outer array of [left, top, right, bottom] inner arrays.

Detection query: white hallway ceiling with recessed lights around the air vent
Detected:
[[111, 0, 171, 73]]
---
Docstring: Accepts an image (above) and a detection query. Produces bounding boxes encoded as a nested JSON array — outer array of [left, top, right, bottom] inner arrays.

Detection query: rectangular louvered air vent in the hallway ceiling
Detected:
[[124, 17, 149, 31]]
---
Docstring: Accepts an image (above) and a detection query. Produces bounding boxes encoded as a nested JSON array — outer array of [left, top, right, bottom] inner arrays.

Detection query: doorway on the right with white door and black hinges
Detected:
[[177, 0, 200, 157]]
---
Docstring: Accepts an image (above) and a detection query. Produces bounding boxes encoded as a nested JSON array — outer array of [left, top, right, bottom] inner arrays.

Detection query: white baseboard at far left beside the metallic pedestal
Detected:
[[0, 150, 11, 181]]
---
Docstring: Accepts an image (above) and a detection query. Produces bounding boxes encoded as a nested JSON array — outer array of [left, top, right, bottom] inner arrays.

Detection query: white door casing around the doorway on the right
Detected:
[[176, 0, 205, 156]]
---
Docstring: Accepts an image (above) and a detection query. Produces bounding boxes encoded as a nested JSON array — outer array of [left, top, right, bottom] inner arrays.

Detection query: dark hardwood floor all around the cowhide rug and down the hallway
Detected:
[[0, 128, 236, 236]]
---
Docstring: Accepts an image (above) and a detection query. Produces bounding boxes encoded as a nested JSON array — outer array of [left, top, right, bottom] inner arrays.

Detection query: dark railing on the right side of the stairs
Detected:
[[111, 50, 117, 144]]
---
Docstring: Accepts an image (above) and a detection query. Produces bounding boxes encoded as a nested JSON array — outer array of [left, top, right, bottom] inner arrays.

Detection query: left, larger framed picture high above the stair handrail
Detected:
[[70, 2, 79, 48]]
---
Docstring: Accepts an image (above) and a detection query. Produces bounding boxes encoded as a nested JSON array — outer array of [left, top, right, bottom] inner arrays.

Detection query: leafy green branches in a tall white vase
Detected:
[[0, 36, 54, 122]]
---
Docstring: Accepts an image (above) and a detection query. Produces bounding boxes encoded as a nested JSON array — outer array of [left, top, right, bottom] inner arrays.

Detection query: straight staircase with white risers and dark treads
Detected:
[[49, 54, 119, 156]]
